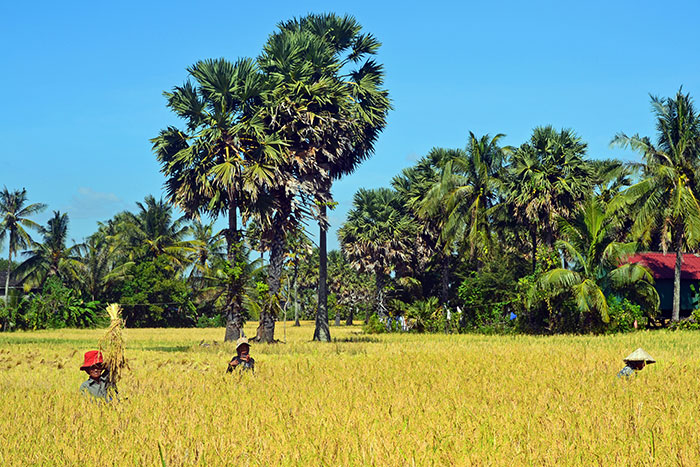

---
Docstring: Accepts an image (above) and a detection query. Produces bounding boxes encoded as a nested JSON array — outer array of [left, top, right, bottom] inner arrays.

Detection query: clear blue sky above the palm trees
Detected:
[[0, 0, 700, 256]]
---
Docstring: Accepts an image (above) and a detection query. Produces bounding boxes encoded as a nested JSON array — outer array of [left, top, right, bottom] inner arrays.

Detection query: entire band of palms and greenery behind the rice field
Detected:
[[0, 14, 700, 342]]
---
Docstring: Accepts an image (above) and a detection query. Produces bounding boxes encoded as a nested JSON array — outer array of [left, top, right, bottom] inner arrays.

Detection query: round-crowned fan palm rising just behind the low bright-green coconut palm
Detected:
[[507, 126, 592, 272]]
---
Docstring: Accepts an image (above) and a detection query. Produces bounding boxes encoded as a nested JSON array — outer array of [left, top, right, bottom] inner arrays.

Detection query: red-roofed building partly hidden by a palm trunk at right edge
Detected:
[[628, 252, 700, 317]]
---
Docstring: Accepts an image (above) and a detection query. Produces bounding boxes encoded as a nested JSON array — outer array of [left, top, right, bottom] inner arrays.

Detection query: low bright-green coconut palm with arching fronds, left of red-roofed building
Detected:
[[536, 199, 659, 323]]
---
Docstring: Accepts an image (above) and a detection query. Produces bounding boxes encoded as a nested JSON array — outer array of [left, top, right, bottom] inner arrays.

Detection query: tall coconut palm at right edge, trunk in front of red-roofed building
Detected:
[[611, 89, 700, 321]]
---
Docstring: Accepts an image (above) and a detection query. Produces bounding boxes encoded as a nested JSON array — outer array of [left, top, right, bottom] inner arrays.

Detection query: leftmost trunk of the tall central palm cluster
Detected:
[[224, 200, 245, 341]]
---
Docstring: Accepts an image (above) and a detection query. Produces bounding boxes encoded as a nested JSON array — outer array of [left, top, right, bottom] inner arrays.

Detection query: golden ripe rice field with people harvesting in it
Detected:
[[0, 323, 700, 466]]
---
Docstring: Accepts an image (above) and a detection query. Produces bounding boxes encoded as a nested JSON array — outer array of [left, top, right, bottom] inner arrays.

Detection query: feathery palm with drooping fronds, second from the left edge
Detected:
[[16, 211, 81, 287]]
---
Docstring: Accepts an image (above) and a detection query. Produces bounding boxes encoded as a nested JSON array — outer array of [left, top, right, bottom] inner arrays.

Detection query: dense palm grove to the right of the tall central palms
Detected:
[[339, 90, 700, 332]]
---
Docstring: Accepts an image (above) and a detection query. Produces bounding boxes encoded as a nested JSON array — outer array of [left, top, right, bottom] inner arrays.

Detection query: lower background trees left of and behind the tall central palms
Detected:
[[0, 191, 371, 336]]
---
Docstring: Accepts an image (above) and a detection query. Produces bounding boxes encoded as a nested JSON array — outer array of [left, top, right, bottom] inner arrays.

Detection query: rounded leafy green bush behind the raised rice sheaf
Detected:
[[120, 256, 196, 327]]
